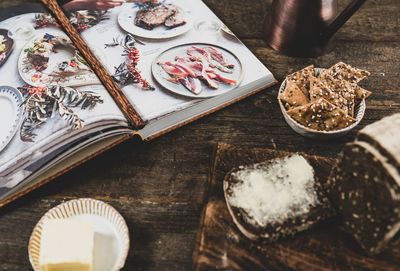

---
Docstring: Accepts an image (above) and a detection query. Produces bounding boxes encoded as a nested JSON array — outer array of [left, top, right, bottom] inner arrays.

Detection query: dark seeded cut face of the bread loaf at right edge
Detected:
[[326, 141, 400, 255]]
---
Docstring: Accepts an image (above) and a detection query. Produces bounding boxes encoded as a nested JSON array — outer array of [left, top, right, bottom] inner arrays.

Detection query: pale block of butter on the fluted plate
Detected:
[[40, 219, 94, 271]]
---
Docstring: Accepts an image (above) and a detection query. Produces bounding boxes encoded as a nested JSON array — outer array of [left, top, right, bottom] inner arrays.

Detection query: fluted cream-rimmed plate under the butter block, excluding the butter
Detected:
[[28, 199, 129, 271]]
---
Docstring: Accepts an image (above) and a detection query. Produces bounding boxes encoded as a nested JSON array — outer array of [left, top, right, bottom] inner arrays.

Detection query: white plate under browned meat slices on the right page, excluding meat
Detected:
[[118, 4, 192, 40]]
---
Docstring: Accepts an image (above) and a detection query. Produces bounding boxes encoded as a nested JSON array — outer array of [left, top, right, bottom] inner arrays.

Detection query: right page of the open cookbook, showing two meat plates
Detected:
[[58, 0, 274, 121]]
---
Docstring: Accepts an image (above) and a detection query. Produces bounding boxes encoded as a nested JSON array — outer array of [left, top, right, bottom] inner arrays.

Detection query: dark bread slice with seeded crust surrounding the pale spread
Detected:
[[223, 154, 334, 241]]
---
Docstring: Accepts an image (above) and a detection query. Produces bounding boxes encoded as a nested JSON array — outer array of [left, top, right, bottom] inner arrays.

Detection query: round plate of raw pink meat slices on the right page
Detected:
[[152, 43, 243, 98]]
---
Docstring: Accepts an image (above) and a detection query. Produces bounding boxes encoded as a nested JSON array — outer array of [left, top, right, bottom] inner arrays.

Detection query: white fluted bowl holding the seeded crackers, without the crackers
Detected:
[[278, 68, 366, 139]]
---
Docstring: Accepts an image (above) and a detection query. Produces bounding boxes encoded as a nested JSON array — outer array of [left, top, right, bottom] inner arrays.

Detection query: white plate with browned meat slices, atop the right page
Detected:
[[118, 4, 192, 39]]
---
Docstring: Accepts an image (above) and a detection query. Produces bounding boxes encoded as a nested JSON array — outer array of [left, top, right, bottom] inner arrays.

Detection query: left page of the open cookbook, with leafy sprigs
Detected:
[[0, 1, 127, 188]]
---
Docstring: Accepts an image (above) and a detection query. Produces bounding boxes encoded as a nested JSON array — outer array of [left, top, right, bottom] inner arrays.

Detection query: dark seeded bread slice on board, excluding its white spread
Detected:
[[224, 155, 334, 242]]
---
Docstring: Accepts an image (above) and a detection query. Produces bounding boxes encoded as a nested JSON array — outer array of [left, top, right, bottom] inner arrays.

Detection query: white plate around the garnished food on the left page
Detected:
[[18, 33, 100, 87]]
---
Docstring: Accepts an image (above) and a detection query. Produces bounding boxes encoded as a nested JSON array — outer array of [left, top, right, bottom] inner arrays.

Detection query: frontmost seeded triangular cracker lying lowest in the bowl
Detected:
[[288, 98, 356, 131]]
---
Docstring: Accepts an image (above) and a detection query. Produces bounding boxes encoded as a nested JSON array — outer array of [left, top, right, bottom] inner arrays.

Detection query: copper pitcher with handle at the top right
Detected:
[[266, 0, 366, 57]]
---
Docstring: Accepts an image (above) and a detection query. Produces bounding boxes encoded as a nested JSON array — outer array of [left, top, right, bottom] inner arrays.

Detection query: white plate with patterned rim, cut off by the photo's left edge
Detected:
[[0, 86, 23, 153]]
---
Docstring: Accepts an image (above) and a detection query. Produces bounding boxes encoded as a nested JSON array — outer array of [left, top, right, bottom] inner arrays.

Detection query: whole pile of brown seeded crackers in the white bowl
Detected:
[[279, 62, 371, 131]]
